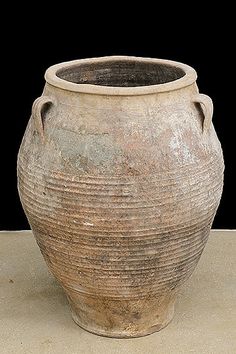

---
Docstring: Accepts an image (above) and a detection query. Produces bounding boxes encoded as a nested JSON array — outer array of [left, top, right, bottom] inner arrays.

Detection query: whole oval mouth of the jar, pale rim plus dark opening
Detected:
[[45, 56, 196, 95]]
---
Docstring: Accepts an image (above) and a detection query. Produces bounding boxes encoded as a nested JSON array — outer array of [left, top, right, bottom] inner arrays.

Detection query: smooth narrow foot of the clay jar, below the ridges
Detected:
[[69, 297, 174, 338]]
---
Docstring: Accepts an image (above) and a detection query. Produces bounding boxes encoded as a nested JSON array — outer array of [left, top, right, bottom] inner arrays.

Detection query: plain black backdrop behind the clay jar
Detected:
[[0, 9, 236, 230]]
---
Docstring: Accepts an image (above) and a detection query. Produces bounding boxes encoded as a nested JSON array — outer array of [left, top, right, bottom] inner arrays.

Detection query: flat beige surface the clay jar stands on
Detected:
[[0, 230, 236, 354]]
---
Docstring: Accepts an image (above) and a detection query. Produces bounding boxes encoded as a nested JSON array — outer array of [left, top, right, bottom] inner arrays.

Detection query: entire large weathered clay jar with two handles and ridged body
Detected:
[[18, 57, 224, 337]]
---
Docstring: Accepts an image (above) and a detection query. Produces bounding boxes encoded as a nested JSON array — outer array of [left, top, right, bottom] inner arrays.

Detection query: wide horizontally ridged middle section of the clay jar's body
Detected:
[[18, 149, 223, 299]]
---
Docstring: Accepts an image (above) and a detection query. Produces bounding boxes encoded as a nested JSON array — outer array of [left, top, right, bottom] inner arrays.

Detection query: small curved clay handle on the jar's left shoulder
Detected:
[[32, 96, 53, 142]]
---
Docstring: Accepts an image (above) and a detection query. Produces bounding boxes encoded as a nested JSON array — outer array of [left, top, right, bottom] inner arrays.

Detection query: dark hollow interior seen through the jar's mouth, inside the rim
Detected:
[[57, 60, 185, 87]]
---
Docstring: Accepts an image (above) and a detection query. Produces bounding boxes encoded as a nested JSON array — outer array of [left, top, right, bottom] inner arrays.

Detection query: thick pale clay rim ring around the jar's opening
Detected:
[[45, 55, 197, 96]]
